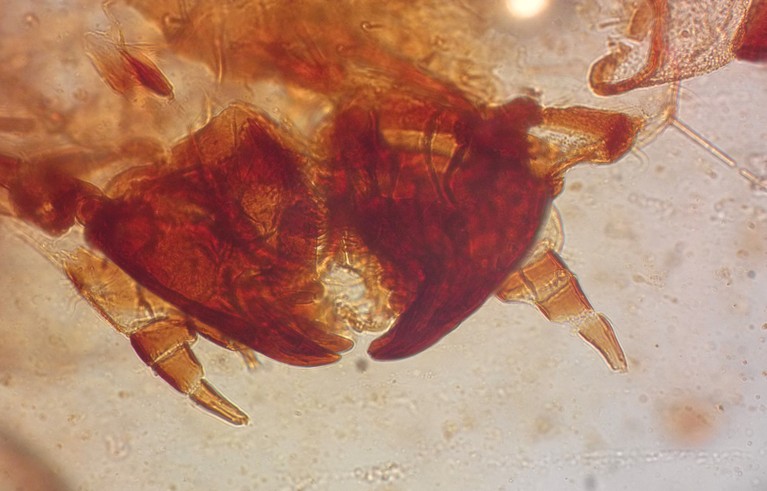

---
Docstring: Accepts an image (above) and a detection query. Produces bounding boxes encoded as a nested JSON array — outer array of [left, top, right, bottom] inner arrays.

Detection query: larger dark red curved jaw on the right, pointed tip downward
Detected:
[[329, 98, 552, 360]]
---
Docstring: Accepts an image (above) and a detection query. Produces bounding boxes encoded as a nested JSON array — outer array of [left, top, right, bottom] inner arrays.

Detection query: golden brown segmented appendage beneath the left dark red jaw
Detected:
[[63, 248, 258, 426]]
